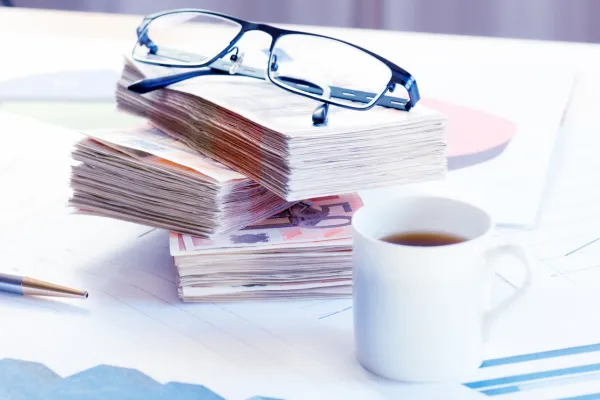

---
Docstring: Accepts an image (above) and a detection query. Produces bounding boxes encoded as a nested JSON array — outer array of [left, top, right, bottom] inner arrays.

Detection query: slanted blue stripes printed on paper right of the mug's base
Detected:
[[464, 343, 600, 400]]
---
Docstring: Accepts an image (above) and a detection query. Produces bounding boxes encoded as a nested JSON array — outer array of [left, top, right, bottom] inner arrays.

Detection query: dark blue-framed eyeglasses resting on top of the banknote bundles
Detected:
[[128, 9, 420, 125]]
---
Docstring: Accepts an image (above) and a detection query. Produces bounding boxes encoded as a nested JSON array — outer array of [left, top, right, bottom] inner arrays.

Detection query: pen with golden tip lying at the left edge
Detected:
[[0, 273, 88, 299]]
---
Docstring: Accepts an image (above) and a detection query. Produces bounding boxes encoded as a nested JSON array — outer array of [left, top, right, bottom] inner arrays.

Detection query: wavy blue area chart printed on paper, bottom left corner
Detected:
[[0, 359, 278, 400]]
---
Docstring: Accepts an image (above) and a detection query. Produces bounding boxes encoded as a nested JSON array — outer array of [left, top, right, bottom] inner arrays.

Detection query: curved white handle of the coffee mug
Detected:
[[484, 243, 532, 339]]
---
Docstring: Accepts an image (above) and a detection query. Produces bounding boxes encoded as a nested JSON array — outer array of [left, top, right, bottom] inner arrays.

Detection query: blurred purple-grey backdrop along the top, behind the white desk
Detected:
[[0, 0, 600, 42]]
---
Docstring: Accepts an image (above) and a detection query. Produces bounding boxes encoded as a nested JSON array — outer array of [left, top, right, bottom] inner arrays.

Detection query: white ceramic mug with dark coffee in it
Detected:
[[352, 196, 531, 382]]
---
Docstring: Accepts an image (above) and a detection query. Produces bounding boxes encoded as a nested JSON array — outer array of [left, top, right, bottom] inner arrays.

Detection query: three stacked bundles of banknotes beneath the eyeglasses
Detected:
[[71, 57, 447, 302]]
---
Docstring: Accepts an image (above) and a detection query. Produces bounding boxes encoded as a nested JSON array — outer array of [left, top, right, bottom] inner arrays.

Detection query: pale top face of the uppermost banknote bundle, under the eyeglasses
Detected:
[[124, 56, 444, 137]]
